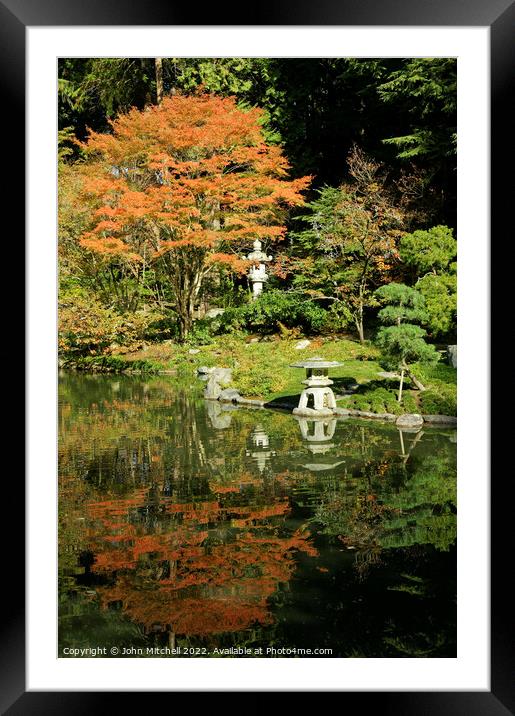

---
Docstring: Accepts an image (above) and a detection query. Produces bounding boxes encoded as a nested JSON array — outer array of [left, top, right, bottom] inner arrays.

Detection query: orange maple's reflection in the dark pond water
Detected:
[[88, 490, 317, 636]]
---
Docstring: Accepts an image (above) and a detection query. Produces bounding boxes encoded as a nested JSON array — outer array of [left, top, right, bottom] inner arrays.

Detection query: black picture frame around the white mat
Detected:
[[7, 0, 515, 716]]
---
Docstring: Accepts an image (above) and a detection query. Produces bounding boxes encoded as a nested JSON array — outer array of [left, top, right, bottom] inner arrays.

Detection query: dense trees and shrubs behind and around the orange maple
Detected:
[[58, 58, 456, 353]]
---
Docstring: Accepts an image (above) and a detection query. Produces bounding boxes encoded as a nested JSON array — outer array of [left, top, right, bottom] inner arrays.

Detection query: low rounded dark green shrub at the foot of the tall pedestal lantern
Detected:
[[219, 291, 327, 334]]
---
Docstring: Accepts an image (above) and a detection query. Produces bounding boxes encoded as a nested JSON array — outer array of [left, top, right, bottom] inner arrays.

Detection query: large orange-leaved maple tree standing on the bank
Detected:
[[76, 93, 311, 338]]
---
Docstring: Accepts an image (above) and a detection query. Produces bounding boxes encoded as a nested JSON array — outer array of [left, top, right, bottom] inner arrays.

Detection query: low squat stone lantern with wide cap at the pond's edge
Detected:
[[290, 356, 343, 417]]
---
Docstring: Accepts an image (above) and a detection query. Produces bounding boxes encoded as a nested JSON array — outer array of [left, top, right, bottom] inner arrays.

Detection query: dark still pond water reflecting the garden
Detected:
[[59, 374, 456, 658]]
